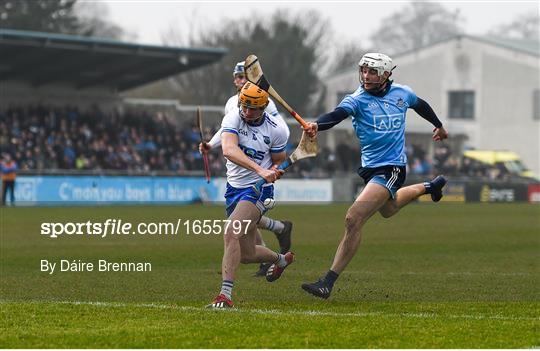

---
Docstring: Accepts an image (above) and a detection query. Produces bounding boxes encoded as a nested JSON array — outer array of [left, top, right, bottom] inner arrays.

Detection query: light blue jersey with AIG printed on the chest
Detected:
[[338, 83, 417, 168]]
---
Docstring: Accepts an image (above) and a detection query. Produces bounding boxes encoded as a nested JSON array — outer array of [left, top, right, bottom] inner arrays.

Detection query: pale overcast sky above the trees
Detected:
[[102, 0, 539, 45]]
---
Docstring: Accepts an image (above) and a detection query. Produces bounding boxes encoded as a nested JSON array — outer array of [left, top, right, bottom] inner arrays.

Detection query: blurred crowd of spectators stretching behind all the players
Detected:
[[0, 105, 524, 179]]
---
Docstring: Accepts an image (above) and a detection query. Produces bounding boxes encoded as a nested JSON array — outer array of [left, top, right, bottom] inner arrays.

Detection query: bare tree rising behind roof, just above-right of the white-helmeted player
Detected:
[[370, 2, 464, 54]]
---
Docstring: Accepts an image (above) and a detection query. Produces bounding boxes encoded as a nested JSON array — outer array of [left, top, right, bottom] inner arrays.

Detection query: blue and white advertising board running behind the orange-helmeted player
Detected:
[[8, 176, 332, 205]]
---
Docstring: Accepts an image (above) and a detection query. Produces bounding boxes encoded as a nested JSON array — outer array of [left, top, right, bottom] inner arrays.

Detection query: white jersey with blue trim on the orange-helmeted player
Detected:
[[221, 108, 289, 188]]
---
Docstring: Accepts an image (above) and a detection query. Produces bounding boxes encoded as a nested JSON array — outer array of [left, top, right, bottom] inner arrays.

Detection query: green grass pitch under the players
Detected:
[[0, 204, 540, 348]]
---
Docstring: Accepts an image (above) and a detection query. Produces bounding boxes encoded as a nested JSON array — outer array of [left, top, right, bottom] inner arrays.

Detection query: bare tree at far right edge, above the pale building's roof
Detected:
[[488, 12, 540, 41]]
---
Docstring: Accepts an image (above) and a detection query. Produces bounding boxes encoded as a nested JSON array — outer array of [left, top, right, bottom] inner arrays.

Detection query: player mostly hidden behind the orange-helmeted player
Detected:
[[199, 61, 293, 277]]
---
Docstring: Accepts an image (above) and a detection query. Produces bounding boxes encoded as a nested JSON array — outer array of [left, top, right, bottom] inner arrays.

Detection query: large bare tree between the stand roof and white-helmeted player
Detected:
[[160, 11, 327, 113]]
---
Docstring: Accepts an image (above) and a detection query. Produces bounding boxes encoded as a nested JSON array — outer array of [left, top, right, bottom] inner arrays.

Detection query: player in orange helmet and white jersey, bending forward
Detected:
[[207, 82, 294, 308]]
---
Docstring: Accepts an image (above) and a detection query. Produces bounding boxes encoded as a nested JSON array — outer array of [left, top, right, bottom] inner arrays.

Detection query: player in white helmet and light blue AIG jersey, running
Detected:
[[302, 53, 448, 299]]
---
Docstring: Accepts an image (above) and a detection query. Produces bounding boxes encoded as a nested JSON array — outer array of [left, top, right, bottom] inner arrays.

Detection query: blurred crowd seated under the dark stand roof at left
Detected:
[[0, 106, 223, 174]]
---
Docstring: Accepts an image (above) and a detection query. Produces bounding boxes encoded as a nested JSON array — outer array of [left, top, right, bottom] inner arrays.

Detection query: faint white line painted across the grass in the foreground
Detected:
[[0, 300, 540, 321]]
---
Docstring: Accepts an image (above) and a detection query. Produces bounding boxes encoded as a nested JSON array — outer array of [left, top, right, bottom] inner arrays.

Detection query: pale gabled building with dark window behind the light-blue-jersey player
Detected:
[[325, 35, 540, 174]]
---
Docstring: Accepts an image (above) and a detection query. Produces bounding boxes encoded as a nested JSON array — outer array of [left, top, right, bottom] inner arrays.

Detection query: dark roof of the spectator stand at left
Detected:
[[0, 29, 227, 91]]
